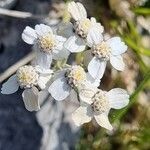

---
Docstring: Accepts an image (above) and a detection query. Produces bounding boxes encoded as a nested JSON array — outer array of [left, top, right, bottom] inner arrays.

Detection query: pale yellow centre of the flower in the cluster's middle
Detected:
[[68, 66, 86, 86]]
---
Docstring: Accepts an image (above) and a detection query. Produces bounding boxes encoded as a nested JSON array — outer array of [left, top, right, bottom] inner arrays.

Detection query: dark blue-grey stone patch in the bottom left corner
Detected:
[[0, 91, 42, 150]]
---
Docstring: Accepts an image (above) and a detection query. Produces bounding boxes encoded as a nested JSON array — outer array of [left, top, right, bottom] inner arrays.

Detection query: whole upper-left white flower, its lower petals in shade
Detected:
[[22, 24, 69, 69]]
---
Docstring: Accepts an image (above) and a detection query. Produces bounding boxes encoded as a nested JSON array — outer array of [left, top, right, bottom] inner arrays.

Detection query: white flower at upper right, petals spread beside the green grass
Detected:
[[87, 30, 127, 79]]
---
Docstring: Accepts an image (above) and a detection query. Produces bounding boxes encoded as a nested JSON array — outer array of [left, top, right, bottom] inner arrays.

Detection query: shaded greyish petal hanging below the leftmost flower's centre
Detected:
[[22, 87, 40, 111]]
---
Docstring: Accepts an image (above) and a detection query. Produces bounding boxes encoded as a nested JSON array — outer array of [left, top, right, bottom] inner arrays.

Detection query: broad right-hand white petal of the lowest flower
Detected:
[[107, 88, 129, 109]]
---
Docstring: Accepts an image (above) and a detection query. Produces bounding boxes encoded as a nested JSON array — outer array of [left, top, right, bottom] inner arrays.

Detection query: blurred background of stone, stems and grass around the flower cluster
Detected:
[[0, 0, 150, 150]]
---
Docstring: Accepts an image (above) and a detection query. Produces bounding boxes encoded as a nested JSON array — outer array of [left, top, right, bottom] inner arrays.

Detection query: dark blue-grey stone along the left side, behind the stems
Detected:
[[0, 0, 48, 150]]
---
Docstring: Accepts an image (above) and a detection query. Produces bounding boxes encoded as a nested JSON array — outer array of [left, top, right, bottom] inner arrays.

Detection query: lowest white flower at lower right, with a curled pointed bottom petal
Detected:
[[72, 88, 129, 130]]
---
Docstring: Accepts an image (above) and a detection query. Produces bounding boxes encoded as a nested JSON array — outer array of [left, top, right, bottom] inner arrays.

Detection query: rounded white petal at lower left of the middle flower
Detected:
[[48, 77, 71, 101]]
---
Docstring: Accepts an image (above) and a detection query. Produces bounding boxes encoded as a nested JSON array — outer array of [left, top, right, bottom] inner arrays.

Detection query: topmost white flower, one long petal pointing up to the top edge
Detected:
[[64, 2, 104, 53]]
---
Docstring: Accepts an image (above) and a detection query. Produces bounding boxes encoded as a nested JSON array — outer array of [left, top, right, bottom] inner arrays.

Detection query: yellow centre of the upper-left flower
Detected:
[[38, 34, 56, 52]]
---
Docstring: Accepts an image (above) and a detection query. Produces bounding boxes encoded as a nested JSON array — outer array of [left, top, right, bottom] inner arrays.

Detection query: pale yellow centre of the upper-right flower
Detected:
[[92, 41, 111, 60]]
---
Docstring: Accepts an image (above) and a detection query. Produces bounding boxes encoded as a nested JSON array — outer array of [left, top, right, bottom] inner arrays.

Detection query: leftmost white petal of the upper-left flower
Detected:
[[22, 26, 37, 44]]
